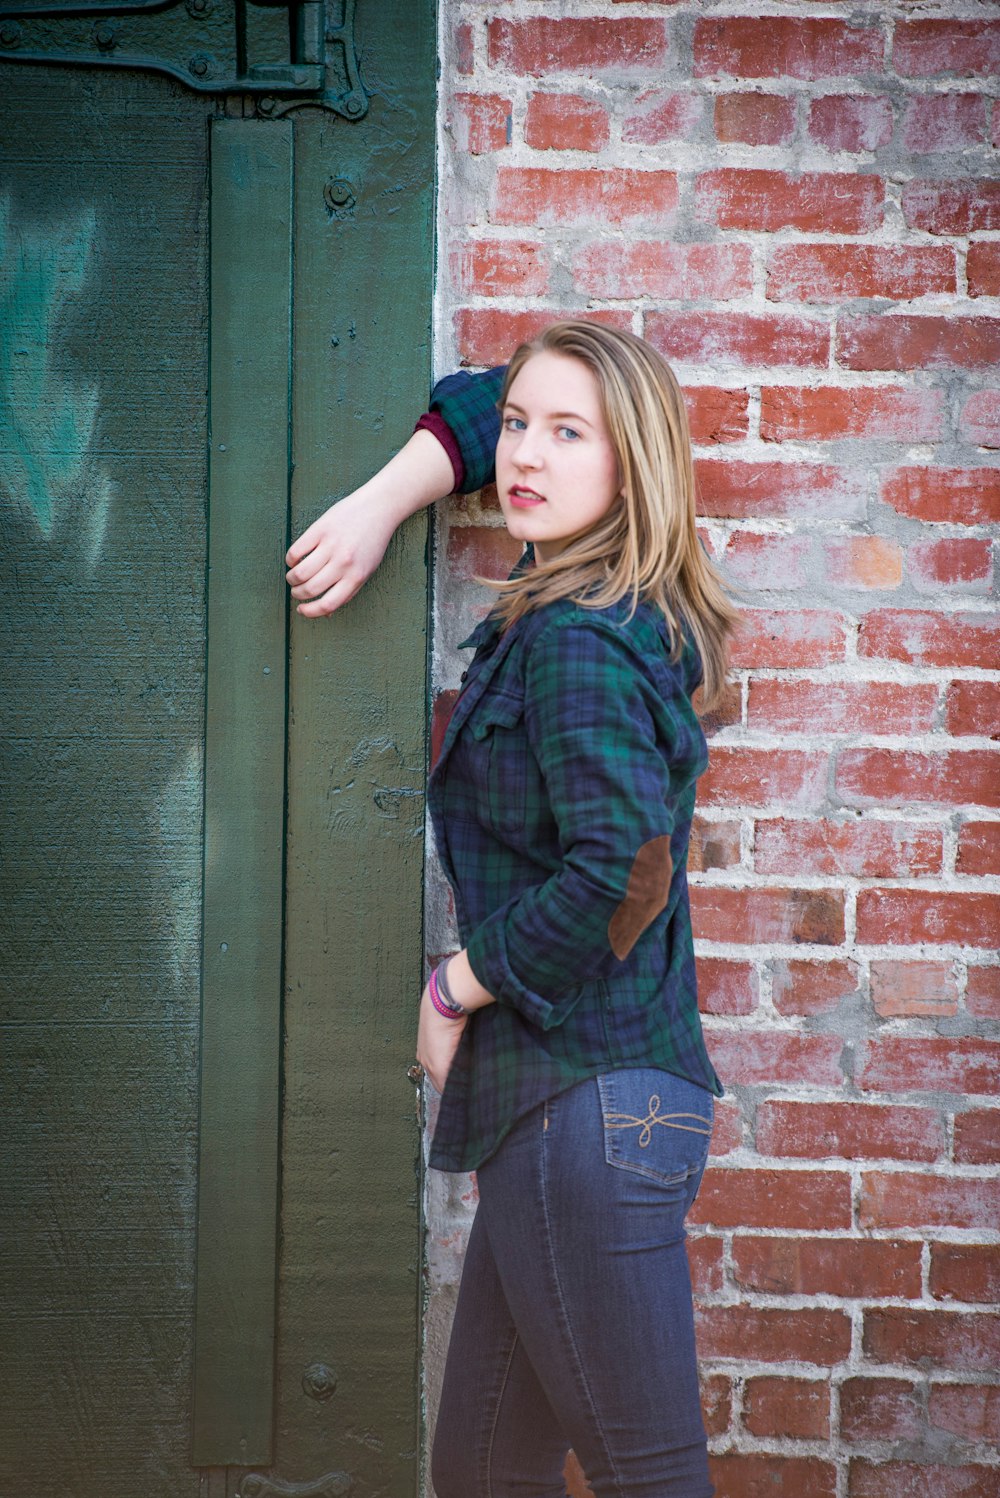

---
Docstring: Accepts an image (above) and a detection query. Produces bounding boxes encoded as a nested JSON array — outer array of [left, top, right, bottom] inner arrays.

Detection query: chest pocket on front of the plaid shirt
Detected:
[[469, 692, 546, 842]]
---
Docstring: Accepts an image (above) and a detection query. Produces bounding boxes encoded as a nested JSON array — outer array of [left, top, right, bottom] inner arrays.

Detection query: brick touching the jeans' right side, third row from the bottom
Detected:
[[698, 1305, 850, 1366]]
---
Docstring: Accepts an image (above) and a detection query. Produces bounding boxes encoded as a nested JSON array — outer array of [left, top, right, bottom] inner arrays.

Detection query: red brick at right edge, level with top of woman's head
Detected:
[[837, 315, 1000, 370]]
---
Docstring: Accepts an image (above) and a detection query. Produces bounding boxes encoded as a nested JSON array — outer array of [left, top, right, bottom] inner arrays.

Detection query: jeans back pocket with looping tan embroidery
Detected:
[[597, 1067, 713, 1182]]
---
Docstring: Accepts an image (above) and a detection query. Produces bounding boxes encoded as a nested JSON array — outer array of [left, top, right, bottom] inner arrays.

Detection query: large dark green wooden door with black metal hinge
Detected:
[[0, 0, 434, 1498]]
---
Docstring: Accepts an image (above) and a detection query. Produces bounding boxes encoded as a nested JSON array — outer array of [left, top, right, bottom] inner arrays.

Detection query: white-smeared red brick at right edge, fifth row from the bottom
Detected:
[[858, 1170, 1000, 1234]]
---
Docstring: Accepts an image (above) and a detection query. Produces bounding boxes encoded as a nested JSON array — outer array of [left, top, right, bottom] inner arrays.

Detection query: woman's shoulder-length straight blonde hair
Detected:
[[493, 321, 738, 712]]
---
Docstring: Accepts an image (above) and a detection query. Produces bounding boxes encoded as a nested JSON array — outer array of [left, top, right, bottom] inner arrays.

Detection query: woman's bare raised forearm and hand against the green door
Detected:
[[284, 430, 454, 619]]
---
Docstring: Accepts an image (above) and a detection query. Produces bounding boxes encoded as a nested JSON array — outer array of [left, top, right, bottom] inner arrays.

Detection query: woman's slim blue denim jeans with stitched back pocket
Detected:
[[433, 1068, 714, 1498]]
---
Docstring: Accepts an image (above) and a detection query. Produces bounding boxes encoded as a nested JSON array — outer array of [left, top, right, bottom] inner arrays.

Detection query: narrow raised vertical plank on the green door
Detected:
[[193, 120, 292, 1467]]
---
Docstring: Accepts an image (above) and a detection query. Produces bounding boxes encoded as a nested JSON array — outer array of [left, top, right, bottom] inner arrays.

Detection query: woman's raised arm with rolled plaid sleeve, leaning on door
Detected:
[[284, 369, 503, 619]]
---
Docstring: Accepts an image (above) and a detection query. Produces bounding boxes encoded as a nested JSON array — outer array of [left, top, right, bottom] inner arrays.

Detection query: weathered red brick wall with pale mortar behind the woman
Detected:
[[428, 0, 1000, 1498]]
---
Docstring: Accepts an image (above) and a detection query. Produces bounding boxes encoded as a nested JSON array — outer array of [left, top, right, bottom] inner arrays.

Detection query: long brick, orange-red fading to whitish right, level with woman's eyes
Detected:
[[760, 385, 945, 442]]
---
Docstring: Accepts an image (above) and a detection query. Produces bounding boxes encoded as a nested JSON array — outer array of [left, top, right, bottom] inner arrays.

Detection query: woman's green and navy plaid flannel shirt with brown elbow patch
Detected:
[[430, 370, 722, 1170]]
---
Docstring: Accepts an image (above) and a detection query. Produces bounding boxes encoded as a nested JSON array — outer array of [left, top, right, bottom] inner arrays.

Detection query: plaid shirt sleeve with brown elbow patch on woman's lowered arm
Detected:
[[467, 616, 690, 1029]]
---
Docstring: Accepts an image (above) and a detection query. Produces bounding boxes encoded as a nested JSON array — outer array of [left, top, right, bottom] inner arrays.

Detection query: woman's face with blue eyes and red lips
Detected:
[[497, 351, 621, 562]]
